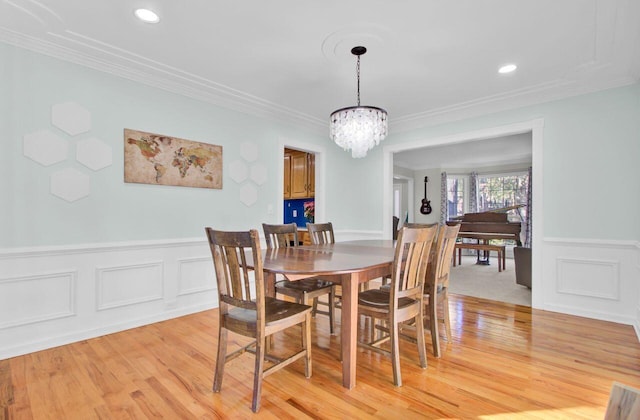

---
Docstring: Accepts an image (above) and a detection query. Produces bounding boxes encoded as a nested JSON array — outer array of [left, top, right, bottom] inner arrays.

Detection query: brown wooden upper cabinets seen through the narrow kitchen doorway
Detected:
[[284, 149, 315, 199]]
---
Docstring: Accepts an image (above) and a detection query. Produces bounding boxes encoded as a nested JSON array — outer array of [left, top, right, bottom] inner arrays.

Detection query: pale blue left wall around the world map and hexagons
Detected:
[[0, 43, 342, 248]]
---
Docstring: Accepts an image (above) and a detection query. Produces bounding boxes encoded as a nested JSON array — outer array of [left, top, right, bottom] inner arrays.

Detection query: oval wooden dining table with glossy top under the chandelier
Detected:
[[263, 240, 394, 389]]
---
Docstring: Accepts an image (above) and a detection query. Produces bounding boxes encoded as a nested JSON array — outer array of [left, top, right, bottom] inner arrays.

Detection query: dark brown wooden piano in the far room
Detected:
[[447, 205, 522, 246]]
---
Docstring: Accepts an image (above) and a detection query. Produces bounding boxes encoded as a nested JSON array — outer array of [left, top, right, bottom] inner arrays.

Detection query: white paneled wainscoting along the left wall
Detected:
[[0, 235, 217, 359]]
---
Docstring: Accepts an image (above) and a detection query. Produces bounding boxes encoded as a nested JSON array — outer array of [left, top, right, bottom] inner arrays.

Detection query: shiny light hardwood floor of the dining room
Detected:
[[0, 295, 640, 419]]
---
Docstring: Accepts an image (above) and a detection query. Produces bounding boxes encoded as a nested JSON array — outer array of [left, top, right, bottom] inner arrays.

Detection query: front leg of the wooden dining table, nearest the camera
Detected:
[[340, 273, 360, 389]]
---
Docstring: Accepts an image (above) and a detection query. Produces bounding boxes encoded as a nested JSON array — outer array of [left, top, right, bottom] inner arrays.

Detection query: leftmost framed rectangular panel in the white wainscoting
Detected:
[[0, 271, 77, 329]]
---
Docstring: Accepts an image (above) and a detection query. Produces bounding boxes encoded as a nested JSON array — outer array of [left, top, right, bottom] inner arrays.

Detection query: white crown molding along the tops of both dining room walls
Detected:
[[0, 27, 638, 135]]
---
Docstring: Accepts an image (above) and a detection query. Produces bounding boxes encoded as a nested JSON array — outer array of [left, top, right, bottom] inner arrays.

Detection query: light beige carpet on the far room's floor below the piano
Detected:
[[449, 256, 531, 306]]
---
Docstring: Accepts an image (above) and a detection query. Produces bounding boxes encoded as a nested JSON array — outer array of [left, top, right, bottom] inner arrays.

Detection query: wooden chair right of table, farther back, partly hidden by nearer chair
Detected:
[[424, 224, 460, 357]]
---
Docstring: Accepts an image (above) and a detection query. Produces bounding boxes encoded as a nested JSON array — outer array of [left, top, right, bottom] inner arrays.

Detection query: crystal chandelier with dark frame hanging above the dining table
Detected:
[[329, 47, 387, 158]]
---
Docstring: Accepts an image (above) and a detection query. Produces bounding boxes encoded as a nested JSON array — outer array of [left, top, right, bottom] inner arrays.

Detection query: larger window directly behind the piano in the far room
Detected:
[[478, 172, 529, 222]]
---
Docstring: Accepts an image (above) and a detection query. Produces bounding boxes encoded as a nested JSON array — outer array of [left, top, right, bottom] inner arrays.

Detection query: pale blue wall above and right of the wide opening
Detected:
[[378, 84, 640, 240]]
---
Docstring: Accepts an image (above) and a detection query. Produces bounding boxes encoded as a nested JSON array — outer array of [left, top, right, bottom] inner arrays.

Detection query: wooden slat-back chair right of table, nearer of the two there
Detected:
[[358, 226, 438, 386]]
